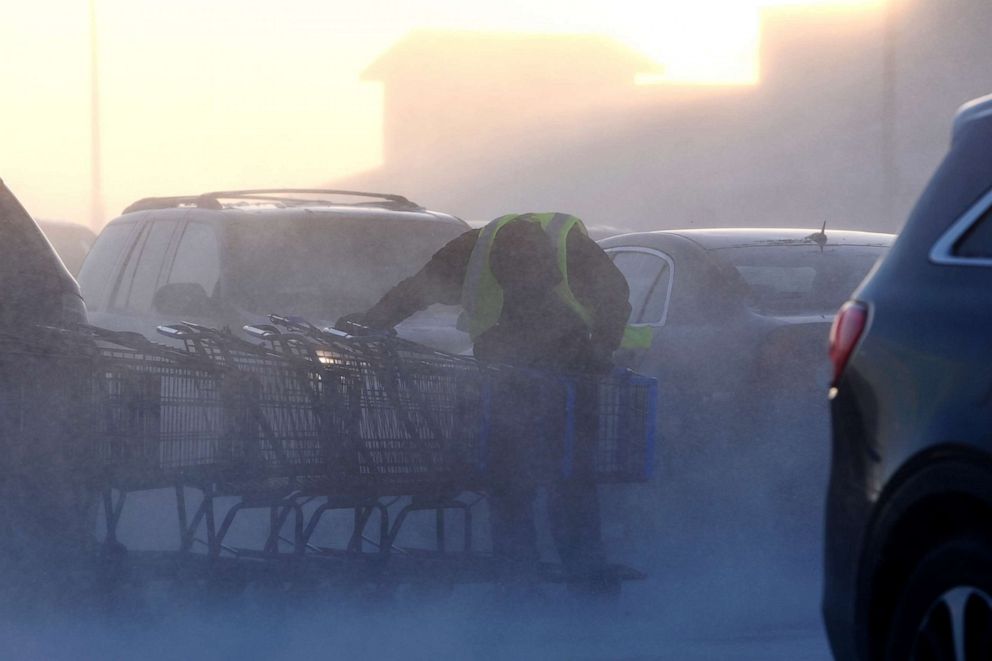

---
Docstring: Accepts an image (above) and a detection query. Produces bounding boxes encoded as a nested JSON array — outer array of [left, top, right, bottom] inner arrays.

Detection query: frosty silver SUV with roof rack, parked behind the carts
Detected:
[[79, 189, 469, 351]]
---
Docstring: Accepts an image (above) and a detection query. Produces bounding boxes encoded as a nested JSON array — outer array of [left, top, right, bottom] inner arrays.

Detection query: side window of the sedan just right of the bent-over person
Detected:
[[611, 248, 672, 325]]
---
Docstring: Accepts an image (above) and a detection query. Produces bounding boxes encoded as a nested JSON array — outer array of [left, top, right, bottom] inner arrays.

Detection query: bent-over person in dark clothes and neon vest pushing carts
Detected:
[[342, 213, 630, 587]]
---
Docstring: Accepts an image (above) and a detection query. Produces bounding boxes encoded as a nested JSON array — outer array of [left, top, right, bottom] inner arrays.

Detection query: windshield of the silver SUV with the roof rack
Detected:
[[230, 217, 465, 320]]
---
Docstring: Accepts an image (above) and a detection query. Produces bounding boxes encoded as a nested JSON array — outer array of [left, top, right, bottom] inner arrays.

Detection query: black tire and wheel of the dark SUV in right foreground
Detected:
[[881, 534, 992, 661]]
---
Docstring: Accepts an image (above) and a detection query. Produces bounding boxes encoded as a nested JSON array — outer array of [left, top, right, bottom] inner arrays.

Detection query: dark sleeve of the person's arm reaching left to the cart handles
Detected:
[[364, 229, 481, 328]]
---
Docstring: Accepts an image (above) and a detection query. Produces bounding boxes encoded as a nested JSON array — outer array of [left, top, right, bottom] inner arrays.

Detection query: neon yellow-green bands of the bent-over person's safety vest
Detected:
[[462, 213, 592, 340]]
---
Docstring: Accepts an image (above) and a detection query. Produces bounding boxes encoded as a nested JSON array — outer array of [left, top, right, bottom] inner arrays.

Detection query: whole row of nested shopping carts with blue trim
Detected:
[[7, 316, 657, 592]]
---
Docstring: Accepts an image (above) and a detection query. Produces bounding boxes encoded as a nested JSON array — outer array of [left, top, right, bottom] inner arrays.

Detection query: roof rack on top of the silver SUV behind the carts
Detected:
[[121, 188, 423, 214]]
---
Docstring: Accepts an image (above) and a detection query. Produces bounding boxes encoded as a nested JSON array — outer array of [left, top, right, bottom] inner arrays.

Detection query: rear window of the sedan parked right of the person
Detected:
[[719, 245, 886, 315]]
